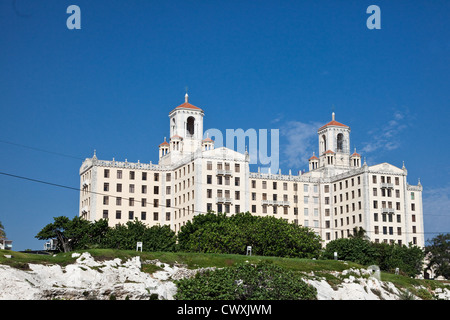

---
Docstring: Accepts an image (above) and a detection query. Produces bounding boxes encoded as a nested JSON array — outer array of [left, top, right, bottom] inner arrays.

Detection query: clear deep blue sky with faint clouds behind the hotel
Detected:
[[0, 0, 450, 250]]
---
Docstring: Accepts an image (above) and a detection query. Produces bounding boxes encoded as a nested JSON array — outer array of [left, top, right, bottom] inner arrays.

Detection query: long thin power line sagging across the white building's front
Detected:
[[0, 171, 450, 235]]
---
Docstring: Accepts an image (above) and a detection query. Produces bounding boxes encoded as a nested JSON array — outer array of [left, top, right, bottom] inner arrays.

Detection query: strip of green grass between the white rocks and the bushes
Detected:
[[0, 249, 449, 298]]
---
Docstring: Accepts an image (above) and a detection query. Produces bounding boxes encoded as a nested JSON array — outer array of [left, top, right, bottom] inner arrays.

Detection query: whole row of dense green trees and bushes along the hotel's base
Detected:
[[32, 212, 440, 276]]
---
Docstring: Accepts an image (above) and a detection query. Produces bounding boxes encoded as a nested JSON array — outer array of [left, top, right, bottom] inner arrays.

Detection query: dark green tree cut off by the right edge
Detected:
[[425, 233, 450, 279]]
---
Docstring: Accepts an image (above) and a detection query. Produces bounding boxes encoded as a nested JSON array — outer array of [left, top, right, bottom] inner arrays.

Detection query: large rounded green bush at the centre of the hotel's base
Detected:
[[178, 212, 321, 258]]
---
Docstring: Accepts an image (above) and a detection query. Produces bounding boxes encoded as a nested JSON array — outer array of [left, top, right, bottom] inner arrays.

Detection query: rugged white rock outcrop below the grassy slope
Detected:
[[0, 252, 450, 300]]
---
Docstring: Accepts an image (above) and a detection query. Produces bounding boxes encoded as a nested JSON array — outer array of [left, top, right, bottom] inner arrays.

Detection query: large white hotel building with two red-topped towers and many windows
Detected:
[[79, 94, 424, 247]]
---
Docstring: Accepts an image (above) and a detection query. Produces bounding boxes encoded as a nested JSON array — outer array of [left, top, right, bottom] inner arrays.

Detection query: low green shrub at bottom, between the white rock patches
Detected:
[[175, 263, 317, 300]]
